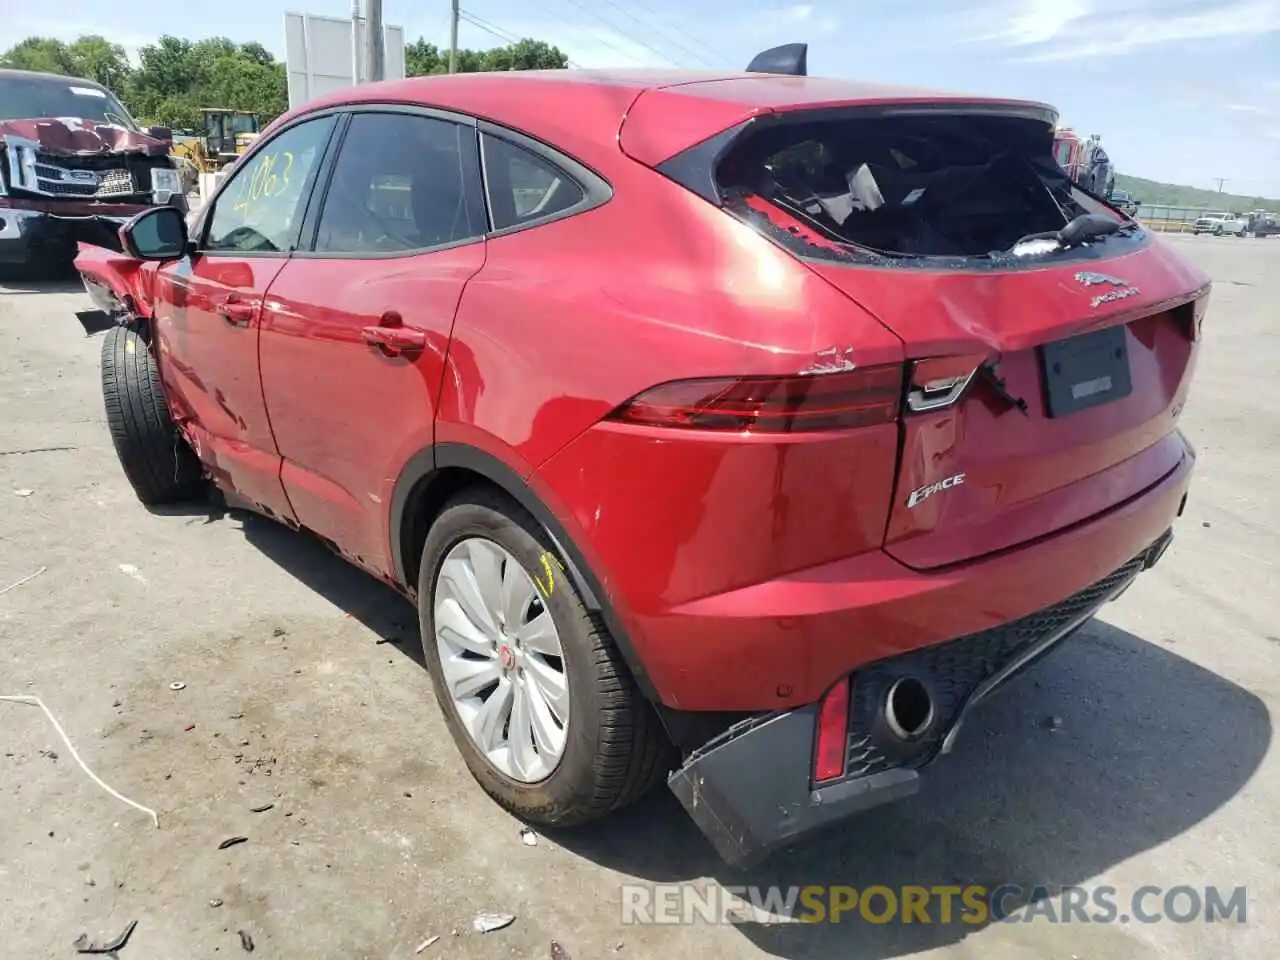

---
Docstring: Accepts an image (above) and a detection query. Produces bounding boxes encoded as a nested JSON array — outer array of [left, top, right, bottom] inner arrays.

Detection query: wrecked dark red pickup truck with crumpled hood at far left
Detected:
[[0, 70, 187, 273]]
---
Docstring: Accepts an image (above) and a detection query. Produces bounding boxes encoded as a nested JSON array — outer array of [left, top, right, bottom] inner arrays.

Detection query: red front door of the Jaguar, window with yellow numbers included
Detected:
[[156, 116, 335, 518]]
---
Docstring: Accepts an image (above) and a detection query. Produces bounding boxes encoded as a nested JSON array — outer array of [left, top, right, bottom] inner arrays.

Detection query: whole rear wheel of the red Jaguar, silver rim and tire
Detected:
[[419, 490, 671, 826]]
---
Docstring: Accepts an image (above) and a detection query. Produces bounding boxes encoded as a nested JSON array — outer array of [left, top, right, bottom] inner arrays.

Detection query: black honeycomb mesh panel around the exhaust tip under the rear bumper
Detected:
[[845, 554, 1146, 780]]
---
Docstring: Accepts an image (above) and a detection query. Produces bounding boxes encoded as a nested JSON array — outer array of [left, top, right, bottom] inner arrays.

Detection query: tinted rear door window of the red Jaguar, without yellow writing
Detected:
[[315, 113, 485, 253]]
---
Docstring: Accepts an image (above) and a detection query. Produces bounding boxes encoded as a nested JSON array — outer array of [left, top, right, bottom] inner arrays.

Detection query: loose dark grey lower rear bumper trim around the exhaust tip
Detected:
[[668, 531, 1172, 865]]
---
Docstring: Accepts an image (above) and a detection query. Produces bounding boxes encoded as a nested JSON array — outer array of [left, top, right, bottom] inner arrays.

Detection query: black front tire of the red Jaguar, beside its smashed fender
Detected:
[[102, 326, 205, 507]]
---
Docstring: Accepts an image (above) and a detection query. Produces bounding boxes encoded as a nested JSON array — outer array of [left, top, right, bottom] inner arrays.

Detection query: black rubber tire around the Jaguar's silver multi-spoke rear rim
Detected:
[[419, 488, 672, 827]]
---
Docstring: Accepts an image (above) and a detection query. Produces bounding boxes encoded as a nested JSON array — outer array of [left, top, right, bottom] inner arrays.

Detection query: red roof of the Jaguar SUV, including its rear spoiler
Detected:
[[282, 69, 1057, 170]]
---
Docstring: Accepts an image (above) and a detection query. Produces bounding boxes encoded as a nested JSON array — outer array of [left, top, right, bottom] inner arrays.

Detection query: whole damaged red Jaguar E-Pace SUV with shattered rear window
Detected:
[[77, 47, 1208, 863]]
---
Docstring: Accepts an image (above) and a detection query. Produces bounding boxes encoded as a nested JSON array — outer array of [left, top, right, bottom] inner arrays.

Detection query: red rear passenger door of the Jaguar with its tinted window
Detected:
[[261, 109, 485, 575]]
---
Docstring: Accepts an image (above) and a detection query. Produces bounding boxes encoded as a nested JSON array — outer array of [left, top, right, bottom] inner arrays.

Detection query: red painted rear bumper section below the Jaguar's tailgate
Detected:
[[643, 434, 1194, 713]]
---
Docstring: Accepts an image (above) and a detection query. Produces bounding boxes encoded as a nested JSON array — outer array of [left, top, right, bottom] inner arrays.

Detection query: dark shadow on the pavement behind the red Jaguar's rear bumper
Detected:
[[549, 621, 1271, 960]]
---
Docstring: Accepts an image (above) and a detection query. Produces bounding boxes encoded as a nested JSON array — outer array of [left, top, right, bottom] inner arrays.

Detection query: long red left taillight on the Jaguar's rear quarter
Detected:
[[609, 364, 902, 433]]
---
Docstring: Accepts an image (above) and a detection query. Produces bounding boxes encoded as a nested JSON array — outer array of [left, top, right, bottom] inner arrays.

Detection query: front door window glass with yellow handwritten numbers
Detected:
[[205, 116, 334, 253]]
